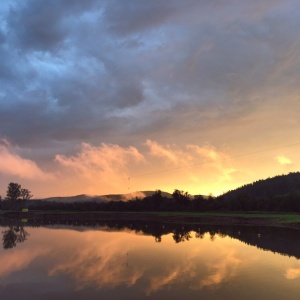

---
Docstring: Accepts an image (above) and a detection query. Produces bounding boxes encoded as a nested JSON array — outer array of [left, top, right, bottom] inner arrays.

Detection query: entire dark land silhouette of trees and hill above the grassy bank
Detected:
[[0, 172, 300, 212]]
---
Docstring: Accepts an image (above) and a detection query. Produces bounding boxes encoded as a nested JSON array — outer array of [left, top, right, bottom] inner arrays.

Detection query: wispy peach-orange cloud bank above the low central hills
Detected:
[[51, 140, 235, 196]]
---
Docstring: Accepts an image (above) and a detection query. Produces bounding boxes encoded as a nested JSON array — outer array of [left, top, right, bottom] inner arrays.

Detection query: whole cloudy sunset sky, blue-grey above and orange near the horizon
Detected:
[[0, 0, 300, 198]]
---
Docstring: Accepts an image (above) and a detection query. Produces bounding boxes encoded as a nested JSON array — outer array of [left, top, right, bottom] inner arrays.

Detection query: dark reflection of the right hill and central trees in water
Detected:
[[89, 220, 300, 259]]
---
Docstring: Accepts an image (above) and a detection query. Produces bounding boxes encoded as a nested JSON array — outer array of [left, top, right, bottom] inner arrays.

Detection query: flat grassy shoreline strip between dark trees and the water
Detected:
[[0, 211, 300, 229]]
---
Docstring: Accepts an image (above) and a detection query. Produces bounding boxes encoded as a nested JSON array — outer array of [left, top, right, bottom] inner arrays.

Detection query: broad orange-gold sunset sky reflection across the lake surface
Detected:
[[0, 228, 300, 299]]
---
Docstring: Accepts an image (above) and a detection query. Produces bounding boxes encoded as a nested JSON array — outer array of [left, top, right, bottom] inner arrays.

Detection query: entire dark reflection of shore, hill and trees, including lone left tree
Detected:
[[2, 220, 300, 259]]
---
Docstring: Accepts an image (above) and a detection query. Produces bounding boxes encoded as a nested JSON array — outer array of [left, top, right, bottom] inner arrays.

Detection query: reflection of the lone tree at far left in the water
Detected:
[[2, 226, 29, 249]]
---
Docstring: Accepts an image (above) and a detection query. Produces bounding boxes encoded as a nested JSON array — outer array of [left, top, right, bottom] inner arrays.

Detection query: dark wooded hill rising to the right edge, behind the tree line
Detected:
[[221, 172, 300, 199]]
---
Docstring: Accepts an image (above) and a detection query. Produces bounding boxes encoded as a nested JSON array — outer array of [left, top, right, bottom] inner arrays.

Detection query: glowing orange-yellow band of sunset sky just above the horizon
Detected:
[[0, 139, 297, 200]]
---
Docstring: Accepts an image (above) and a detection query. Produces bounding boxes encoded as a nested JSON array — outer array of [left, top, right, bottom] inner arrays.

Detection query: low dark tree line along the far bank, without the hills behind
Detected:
[[0, 190, 300, 212]]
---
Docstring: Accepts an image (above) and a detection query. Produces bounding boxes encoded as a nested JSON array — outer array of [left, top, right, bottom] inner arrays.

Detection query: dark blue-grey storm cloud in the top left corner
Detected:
[[7, 0, 99, 51]]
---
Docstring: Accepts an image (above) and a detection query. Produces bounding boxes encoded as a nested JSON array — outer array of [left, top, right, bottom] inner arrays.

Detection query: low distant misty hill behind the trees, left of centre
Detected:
[[41, 191, 172, 203]]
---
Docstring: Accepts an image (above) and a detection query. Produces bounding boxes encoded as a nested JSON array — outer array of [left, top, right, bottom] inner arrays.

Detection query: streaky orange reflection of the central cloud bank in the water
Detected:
[[48, 231, 249, 295]]
